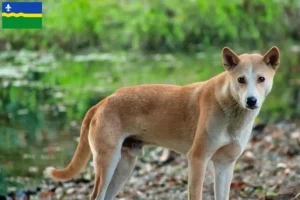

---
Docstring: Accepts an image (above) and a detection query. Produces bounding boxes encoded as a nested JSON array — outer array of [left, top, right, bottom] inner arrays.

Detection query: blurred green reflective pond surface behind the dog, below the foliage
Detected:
[[0, 48, 300, 194]]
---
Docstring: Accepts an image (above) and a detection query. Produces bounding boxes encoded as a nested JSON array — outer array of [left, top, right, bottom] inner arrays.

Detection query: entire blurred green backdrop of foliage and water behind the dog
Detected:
[[0, 0, 300, 194]]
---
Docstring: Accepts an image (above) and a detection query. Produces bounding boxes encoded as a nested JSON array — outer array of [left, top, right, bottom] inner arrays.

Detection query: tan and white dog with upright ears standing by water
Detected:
[[46, 46, 280, 200]]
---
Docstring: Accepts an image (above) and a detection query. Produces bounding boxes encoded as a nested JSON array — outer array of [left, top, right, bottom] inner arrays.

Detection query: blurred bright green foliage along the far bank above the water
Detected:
[[0, 0, 300, 50]]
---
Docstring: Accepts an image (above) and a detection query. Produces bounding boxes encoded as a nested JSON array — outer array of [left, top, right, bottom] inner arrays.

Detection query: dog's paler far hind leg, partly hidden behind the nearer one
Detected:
[[105, 149, 137, 200]]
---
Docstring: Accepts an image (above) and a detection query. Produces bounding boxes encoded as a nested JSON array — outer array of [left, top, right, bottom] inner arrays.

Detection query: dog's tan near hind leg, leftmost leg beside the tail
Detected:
[[89, 116, 124, 200]]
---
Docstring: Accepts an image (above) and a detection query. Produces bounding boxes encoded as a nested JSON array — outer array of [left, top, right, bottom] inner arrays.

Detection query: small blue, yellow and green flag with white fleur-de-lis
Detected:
[[2, 2, 43, 29]]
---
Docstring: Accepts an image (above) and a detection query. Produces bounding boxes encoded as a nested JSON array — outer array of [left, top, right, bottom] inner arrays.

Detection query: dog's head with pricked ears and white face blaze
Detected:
[[222, 47, 280, 110]]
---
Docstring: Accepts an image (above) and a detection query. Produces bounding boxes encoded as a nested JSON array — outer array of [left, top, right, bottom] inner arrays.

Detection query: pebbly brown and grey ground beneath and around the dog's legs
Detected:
[[2, 122, 300, 200]]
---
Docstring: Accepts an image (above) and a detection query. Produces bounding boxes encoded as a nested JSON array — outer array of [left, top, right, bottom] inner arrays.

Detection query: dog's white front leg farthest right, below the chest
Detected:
[[213, 161, 235, 200]]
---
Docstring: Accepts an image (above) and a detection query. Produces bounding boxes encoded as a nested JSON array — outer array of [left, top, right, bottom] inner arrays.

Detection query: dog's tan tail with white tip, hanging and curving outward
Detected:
[[44, 106, 97, 181]]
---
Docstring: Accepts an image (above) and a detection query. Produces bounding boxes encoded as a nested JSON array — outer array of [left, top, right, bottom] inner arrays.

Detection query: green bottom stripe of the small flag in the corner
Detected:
[[2, 16, 43, 29]]
